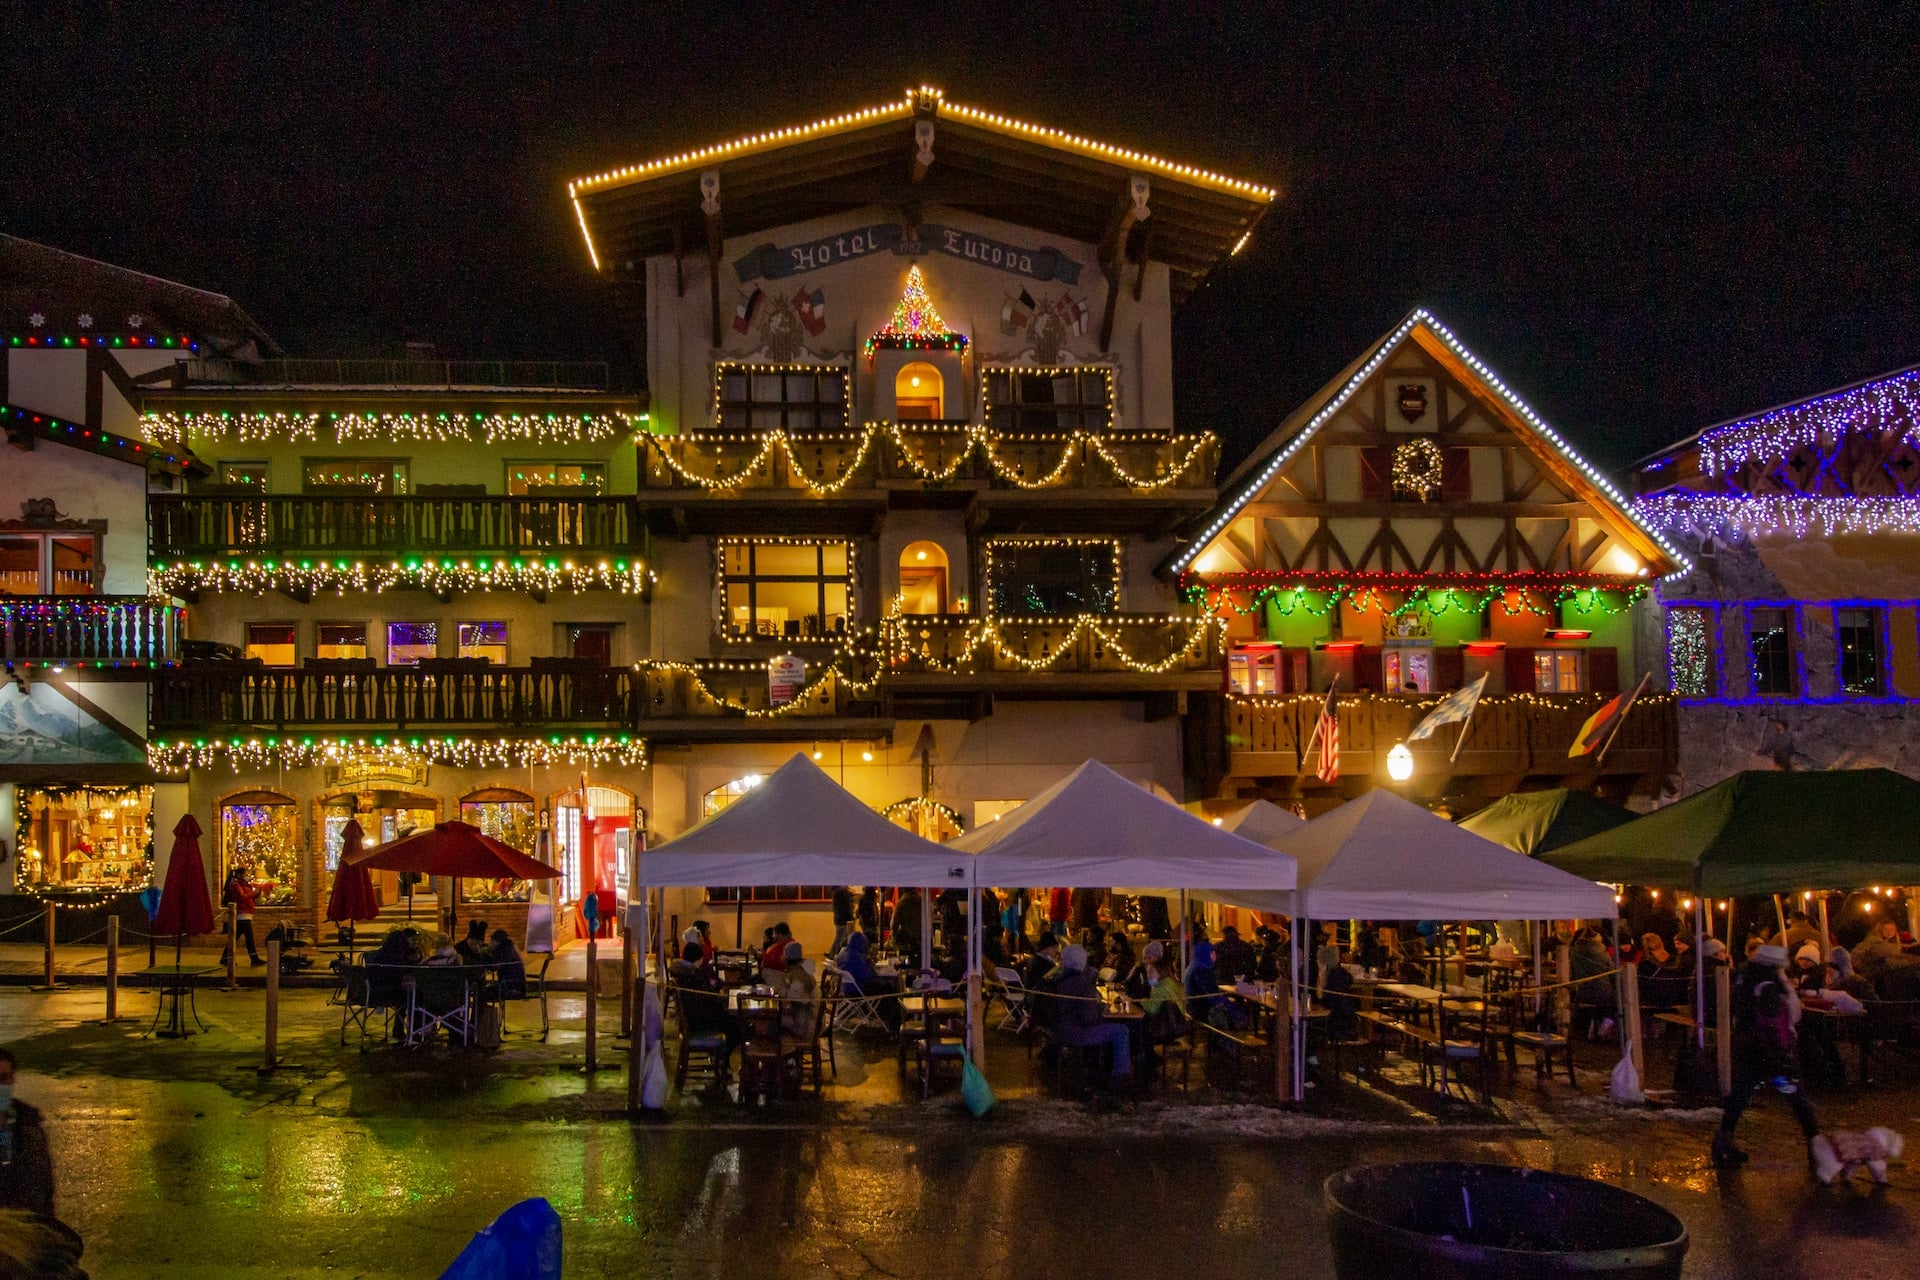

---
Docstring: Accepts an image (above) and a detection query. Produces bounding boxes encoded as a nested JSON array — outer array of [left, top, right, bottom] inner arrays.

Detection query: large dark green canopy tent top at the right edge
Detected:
[[1542, 770, 1920, 898]]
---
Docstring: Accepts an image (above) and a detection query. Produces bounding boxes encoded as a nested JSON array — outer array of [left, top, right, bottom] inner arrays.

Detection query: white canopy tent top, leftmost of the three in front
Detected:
[[639, 756, 973, 889]]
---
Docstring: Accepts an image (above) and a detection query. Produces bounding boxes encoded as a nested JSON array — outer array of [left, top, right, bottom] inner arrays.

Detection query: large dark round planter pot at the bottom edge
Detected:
[[1325, 1163, 1688, 1280]]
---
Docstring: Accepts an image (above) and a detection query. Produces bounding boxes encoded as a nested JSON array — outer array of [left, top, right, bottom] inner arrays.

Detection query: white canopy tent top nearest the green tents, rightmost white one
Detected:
[[1200, 787, 1617, 919]]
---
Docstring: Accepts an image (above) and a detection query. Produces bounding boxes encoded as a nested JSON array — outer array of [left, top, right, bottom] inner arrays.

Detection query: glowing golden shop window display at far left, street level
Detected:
[[15, 787, 154, 890]]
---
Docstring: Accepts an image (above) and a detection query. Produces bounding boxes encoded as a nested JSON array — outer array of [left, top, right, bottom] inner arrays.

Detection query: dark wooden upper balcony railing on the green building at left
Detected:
[[148, 493, 641, 560]]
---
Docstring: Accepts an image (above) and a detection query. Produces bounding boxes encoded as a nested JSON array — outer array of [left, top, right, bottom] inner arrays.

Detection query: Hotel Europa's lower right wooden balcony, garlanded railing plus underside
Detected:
[[881, 614, 1221, 714]]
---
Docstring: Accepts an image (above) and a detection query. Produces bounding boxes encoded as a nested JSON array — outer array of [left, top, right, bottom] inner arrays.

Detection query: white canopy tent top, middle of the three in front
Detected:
[[947, 760, 1294, 892]]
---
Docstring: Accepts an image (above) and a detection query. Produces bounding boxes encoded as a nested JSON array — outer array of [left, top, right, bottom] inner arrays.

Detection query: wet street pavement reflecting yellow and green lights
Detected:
[[0, 988, 1920, 1280]]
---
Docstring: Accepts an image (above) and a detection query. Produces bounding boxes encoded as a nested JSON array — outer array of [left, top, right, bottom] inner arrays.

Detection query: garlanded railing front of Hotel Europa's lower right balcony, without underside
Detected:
[[881, 614, 1221, 681]]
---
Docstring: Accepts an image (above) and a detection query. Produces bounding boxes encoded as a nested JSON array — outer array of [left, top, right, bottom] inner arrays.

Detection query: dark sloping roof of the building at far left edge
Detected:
[[0, 234, 280, 355]]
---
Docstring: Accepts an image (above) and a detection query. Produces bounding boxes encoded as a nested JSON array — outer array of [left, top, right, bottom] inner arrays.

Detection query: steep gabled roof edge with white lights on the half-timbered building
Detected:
[[1160, 307, 1692, 574]]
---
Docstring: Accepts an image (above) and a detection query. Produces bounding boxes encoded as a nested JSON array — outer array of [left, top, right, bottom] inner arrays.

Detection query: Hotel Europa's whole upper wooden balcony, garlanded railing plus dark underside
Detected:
[[639, 420, 1219, 532]]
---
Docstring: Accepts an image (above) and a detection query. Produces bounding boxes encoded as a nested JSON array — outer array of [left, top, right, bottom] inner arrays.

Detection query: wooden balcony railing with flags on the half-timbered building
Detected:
[[1227, 693, 1678, 777]]
